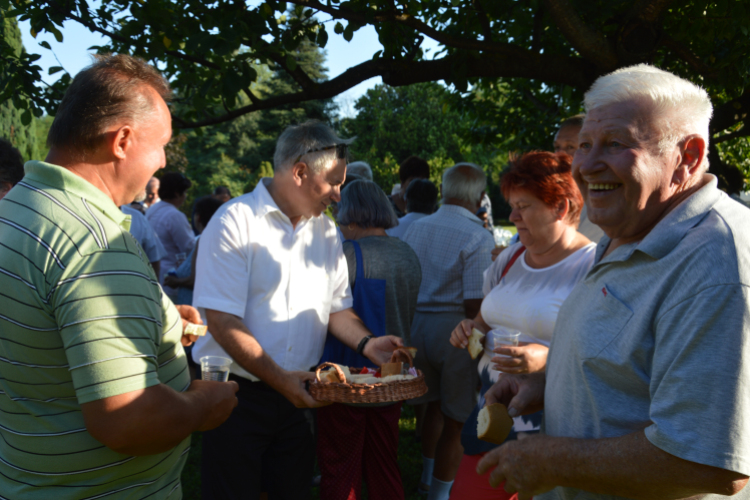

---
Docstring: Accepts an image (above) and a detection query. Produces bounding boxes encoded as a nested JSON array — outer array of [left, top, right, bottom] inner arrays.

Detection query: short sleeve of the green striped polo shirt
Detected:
[[51, 251, 164, 404]]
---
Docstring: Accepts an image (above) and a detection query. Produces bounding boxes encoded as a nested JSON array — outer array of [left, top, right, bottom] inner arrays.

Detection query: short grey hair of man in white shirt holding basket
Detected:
[[273, 120, 354, 174]]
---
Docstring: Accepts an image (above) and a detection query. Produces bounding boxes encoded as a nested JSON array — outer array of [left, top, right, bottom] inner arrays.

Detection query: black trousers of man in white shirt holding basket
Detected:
[[201, 376, 315, 500]]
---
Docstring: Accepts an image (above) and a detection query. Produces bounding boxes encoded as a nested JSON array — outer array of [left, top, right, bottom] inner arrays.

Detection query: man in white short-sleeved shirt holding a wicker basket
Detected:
[[193, 122, 401, 500]]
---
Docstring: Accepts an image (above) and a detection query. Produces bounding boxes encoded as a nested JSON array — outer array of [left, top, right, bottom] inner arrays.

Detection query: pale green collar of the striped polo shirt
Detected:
[[24, 161, 130, 227]]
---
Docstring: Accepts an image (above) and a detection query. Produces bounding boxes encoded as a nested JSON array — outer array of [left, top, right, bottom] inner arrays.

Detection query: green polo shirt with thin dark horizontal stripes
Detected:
[[0, 162, 190, 500]]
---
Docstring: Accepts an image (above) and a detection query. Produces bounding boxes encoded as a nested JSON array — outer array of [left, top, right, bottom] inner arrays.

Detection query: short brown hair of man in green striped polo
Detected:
[[47, 54, 172, 157]]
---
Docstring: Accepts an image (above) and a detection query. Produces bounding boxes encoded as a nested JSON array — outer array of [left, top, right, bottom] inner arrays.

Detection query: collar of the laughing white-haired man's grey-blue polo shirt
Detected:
[[595, 174, 726, 262]]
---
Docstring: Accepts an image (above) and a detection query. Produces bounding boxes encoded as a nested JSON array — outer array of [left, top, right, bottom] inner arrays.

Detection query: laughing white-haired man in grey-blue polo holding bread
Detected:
[[478, 65, 750, 500]]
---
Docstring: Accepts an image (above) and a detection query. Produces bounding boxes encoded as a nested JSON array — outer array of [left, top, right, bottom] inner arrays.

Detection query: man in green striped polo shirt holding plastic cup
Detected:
[[0, 55, 237, 500]]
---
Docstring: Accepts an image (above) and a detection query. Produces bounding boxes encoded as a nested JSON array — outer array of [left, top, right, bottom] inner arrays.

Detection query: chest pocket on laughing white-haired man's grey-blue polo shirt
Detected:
[[579, 285, 633, 359]]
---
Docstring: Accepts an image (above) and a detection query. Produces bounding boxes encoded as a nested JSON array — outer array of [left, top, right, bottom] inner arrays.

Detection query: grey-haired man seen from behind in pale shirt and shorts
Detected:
[[403, 163, 495, 500]]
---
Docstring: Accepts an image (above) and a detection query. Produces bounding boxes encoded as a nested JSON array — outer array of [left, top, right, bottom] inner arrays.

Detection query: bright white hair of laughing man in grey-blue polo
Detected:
[[583, 64, 713, 166]]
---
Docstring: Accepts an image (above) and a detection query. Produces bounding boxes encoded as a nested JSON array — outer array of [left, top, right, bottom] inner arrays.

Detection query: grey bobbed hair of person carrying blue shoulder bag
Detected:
[[336, 179, 398, 229]]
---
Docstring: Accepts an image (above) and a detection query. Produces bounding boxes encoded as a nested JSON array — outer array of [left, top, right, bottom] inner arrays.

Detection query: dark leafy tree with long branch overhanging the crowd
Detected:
[[0, 0, 750, 190]]
